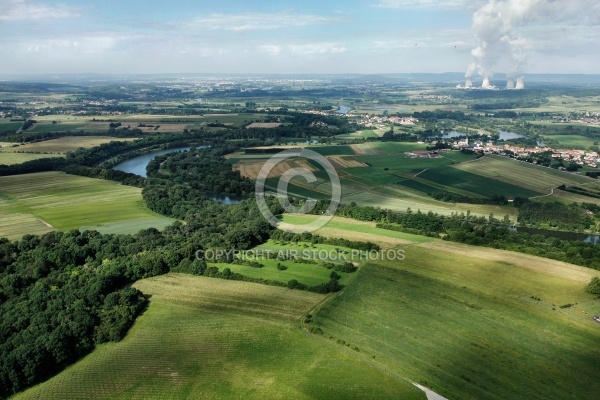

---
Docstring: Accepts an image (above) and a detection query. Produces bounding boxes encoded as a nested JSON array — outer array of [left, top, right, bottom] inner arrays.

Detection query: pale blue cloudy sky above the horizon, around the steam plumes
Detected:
[[0, 0, 600, 74]]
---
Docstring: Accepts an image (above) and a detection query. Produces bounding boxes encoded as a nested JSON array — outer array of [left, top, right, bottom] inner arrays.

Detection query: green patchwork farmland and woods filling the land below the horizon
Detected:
[[0, 75, 600, 400]]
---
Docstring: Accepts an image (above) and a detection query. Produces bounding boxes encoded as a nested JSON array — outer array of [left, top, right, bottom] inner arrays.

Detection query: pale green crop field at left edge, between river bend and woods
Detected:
[[0, 172, 172, 237]]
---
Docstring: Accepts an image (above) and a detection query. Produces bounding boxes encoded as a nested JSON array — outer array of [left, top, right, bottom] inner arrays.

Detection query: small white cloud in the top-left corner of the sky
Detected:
[[0, 0, 80, 21]]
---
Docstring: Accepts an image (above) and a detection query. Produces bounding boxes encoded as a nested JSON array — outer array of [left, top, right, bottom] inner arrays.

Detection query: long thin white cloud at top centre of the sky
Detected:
[[188, 12, 335, 32]]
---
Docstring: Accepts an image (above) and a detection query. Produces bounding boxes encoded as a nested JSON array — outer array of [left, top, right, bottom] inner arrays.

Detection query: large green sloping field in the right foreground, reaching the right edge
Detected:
[[286, 217, 600, 399]]
